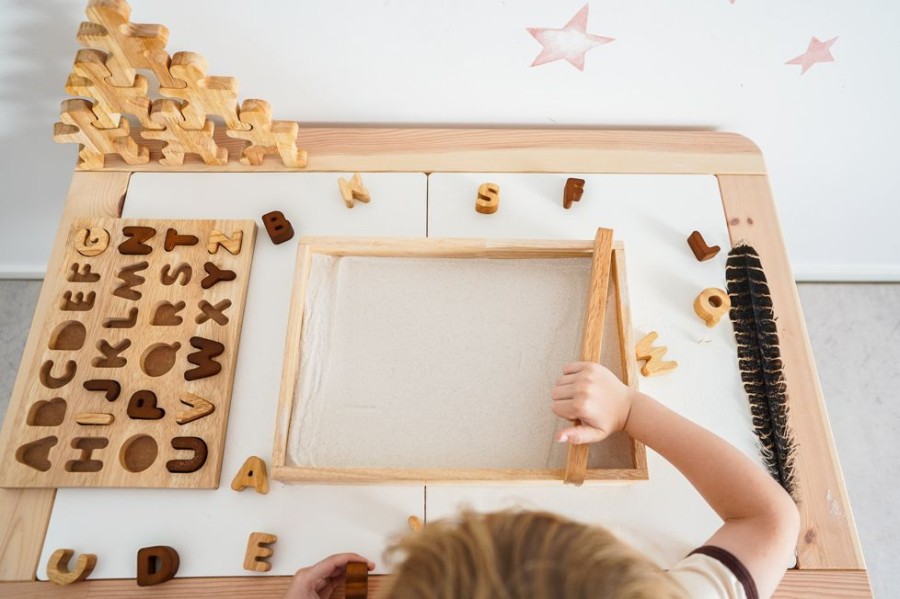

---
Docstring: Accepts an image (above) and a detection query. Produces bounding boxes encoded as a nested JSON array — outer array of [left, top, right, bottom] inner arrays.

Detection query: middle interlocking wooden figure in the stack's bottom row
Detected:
[[141, 99, 228, 166]]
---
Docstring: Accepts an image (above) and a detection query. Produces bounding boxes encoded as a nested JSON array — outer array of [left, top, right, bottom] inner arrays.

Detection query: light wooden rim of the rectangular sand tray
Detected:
[[272, 237, 647, 484]]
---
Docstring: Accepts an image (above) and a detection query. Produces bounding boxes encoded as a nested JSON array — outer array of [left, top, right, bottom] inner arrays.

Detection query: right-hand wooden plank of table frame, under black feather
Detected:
[[719, 176, 865, 569]]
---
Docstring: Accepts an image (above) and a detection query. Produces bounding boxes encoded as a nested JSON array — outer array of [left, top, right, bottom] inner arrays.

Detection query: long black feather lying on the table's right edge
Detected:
[[725, 245, 796, 496]]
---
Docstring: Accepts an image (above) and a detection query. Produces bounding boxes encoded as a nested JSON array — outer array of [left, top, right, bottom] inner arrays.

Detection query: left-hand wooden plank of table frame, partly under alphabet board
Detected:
[[0, 172, 131, 580]]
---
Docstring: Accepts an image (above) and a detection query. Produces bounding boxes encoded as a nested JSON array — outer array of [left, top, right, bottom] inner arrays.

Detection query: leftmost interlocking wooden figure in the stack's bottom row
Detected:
[[53, 99, 150, 169]]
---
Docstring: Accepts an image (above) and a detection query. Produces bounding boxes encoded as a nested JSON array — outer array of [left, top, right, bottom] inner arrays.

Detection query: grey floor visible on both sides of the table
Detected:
[[0, 281, 900, 597]]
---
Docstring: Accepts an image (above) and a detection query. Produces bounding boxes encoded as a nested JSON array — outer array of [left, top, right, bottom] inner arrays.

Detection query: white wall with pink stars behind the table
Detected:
[[0, 0, 900, 280]]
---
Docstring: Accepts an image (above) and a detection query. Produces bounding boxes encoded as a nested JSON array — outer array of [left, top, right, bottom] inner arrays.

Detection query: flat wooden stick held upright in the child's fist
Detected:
[[563, 228, 627, 485]]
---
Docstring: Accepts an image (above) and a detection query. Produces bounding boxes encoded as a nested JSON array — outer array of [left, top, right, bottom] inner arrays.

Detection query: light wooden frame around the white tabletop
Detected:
[[0, 127, 871, 597]]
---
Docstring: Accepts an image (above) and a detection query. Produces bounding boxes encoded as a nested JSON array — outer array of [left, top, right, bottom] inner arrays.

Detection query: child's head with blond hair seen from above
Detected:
[[386, 511, 685, 599]]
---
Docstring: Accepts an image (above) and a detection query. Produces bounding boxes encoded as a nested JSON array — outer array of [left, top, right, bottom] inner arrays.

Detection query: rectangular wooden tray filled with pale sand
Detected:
[[272, 234, 647, 484]]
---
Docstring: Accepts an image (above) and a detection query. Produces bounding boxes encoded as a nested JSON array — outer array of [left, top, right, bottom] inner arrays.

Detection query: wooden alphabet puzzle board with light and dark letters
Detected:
[[0, 218, 256, 489]]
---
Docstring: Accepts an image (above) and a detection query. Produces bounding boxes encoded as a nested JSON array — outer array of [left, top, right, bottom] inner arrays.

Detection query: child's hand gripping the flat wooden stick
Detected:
[[550, 362, 634, 445]]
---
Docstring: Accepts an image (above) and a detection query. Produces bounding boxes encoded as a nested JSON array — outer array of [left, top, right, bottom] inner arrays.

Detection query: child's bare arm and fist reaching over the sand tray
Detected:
[[551, 362, 800, 597]]
